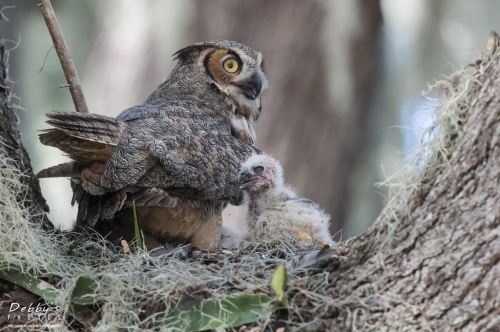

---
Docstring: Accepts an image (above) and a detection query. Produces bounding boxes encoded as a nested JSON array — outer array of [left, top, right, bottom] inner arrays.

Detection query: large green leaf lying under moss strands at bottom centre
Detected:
[[155, 294, 272, 331]]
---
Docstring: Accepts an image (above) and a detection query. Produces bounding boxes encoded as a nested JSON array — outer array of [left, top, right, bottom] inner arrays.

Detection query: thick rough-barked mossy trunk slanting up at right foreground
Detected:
[[312, 31, 500, 331]]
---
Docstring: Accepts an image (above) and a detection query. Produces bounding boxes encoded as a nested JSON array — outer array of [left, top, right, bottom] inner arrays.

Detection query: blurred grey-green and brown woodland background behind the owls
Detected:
[[0, 0, 500, 240]]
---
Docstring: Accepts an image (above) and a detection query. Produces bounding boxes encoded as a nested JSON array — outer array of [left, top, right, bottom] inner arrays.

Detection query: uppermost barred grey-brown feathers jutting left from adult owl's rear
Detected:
[[40, 111, 125, 146]]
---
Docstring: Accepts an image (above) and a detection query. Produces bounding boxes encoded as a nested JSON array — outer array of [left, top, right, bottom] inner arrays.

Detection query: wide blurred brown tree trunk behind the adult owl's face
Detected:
[[191, 0, 382, 233]]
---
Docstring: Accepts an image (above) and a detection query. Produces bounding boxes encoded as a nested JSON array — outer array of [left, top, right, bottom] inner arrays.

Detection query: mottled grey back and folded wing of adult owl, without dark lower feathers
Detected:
[[101, 102, 260, 203]]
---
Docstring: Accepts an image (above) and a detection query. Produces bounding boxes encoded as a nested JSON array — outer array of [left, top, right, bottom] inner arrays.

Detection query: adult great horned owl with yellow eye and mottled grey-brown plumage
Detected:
[[38, 40, 268, 249]]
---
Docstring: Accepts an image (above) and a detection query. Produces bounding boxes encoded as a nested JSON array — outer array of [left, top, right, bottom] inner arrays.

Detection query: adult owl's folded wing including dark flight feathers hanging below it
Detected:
[[48, 105, 259, 225]]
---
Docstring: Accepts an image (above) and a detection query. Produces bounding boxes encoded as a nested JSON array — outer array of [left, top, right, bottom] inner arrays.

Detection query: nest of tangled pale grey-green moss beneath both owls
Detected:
[[0, 150, 346, 331]]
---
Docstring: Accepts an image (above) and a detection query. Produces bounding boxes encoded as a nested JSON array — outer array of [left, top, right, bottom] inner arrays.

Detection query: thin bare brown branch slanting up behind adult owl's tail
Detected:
[[38, 0, 89, 113]]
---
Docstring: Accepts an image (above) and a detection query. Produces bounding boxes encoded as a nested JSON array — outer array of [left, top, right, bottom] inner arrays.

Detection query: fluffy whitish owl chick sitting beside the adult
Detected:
[[238, 154, 332, 243]]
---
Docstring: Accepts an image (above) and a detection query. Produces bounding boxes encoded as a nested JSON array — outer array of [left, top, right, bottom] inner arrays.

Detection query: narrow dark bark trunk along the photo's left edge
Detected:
[[0, 9, 48, 228]]
